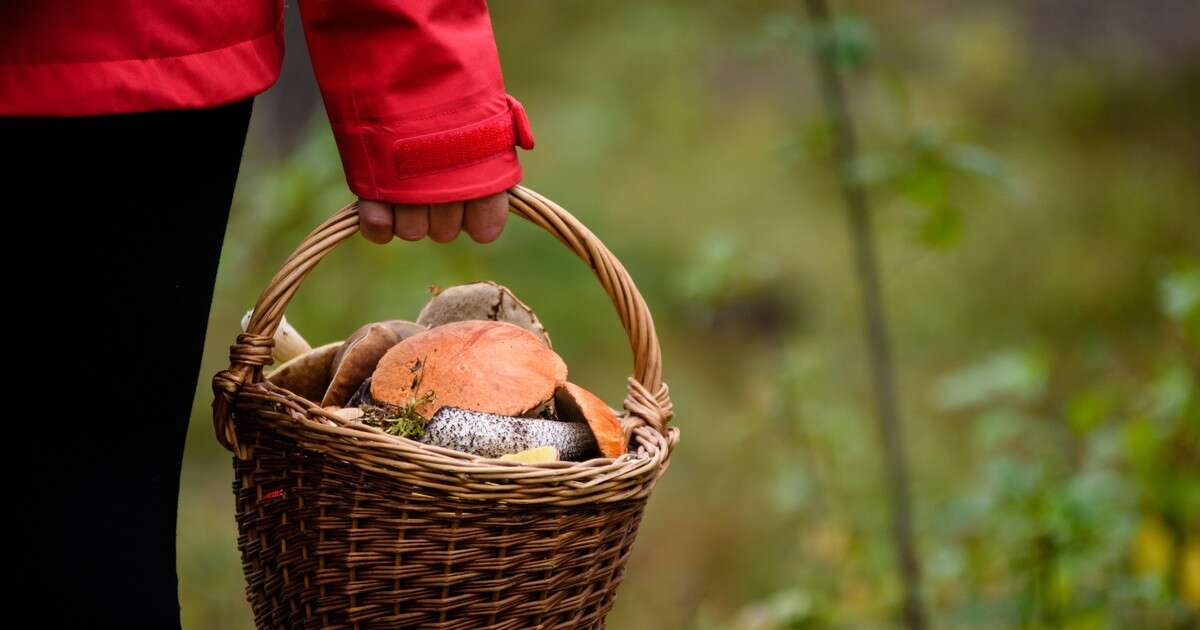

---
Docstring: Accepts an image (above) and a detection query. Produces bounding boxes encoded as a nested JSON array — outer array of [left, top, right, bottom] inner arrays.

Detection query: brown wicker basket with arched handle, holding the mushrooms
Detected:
[[212, 187, 678, 630]]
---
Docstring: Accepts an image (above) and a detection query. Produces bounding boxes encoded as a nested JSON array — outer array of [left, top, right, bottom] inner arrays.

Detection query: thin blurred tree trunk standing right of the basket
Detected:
[[805, 0, 925, 630]]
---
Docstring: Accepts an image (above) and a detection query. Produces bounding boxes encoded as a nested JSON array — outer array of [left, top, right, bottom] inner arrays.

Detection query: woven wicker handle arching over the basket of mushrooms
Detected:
[[212, 186, 672, 458]]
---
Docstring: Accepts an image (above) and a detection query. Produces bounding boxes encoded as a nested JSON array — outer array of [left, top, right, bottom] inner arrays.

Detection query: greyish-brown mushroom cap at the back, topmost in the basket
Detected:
[[416, 281, 553, 347]]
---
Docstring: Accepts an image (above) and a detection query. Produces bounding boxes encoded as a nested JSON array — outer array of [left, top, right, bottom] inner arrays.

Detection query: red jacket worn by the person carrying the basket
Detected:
[[0, 0, 533, 204]]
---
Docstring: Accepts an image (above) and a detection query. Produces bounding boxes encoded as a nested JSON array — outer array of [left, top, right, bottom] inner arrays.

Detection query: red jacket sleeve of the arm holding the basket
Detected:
[[300, 0, 533, 204]]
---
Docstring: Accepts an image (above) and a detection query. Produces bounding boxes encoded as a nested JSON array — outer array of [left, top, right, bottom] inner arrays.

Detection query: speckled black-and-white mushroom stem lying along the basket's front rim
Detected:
[[416, 407, 598, 460]]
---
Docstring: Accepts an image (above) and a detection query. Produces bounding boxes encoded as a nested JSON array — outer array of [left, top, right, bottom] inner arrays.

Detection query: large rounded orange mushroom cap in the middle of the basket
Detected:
[[371, 320, 566, 418]]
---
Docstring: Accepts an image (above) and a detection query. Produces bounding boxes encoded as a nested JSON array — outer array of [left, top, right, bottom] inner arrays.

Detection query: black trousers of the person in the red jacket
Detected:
[[8, 100, 252, 629]]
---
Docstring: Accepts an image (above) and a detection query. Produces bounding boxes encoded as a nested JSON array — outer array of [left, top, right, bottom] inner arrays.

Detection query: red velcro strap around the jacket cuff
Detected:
[[392, 96, 533, 178]]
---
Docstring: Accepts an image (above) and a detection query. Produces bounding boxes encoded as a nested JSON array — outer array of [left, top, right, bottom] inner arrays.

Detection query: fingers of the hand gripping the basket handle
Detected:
[[359, 192, 509, 244]]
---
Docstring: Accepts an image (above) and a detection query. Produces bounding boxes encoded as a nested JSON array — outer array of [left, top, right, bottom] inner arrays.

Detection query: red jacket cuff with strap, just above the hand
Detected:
[[335, 96, 534, 204]]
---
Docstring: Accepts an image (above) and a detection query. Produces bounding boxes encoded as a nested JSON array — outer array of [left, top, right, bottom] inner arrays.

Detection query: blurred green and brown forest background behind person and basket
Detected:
[[179, 0, 1200, 629]]
